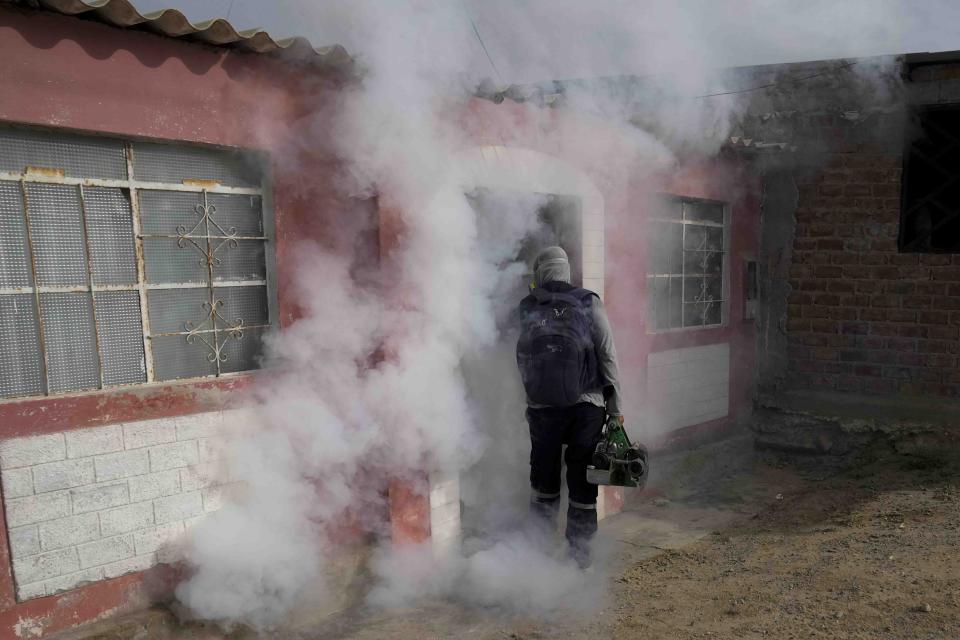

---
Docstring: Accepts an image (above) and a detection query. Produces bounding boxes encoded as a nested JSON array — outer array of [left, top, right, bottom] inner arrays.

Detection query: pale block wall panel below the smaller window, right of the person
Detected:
[[647, 342, 730, 429]]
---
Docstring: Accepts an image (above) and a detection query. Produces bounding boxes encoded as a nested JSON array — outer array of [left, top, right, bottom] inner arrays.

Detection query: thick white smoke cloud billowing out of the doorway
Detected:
[[171, 0, 908, 629]]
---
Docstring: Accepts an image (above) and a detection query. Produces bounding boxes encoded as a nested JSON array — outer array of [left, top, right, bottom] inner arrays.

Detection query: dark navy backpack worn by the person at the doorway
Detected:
[[517, 287, 599, 407]]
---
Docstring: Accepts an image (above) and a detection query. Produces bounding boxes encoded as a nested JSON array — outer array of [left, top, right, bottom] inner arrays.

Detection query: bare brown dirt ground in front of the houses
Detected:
[[65, 430, 960, 640]]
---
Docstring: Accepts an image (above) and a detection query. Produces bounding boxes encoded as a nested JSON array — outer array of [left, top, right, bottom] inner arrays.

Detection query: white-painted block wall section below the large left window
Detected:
[[0, 411, 232, 601]]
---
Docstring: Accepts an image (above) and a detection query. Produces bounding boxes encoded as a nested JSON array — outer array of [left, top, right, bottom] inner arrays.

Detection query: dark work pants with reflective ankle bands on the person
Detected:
[[527, 402, 606, 554]]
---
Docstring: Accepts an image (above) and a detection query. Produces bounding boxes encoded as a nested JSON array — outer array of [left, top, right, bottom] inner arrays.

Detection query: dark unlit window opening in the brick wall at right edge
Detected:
[[900, 106, 960, 253]]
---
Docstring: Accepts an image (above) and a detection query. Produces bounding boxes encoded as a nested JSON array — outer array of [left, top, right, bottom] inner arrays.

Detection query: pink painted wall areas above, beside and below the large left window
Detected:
[[0, 3, 362, 638]]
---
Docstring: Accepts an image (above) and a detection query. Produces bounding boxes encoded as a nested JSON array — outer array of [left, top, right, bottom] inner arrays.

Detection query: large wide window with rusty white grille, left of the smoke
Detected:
[[0, 128, 275, 398]]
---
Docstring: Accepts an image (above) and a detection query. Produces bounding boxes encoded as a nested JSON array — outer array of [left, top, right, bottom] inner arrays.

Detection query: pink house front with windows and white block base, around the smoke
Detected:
[[0, 0, 761, 637]]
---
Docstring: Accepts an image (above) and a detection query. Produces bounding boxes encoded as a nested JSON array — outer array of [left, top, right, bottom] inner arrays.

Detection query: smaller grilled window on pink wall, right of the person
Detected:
[[647, 198, 727, 331]]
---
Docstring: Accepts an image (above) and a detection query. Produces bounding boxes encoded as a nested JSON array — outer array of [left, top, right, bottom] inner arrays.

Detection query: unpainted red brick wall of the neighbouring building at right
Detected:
[[787, 149, 960, 396]]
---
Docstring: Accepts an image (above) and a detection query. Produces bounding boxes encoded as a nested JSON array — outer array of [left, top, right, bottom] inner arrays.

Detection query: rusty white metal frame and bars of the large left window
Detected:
[[0, 122, 279, 404]]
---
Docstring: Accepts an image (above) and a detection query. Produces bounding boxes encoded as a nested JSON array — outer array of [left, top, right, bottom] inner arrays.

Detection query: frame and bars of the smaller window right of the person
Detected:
[[644, 193, 731, 335]]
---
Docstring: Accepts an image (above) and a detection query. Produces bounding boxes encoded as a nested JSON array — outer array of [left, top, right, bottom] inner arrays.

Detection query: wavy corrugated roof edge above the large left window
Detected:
[[13, 0, 352, 65]]
